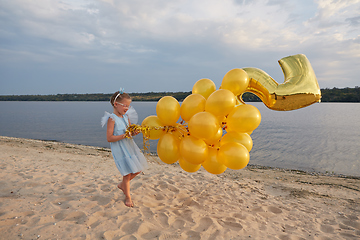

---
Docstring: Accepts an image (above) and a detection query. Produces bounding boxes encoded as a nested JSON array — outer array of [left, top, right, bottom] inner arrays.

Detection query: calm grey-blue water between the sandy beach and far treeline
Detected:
[[0, 102, 360, 176]]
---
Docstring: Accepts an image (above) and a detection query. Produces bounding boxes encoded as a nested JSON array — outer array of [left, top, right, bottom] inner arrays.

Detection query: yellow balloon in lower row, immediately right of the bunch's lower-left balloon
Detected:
[[180, 136, 208, 164]]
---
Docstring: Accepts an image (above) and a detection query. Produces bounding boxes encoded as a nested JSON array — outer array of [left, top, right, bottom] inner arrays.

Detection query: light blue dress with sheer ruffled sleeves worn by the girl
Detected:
[[105, 113, 147, 176]]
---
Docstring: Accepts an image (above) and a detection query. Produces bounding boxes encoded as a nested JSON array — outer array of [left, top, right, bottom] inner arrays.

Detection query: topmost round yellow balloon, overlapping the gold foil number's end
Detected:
[[220, 68, 250, 95]]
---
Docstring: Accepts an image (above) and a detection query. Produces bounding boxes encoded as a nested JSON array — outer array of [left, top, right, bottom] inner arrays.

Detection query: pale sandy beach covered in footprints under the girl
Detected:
[[0, 137, 360, 240]]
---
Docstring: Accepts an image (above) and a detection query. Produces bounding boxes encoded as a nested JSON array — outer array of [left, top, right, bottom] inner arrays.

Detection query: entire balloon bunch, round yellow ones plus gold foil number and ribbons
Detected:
[[128, 54, 321, 174]]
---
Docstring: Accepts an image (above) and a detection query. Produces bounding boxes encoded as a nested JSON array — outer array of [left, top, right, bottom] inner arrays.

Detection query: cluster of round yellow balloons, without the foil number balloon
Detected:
[[141, 69, 261, 174]]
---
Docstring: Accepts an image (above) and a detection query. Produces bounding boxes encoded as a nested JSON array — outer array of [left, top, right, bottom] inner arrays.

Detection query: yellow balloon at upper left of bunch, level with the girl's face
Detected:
[[156, 96, 180, 126]]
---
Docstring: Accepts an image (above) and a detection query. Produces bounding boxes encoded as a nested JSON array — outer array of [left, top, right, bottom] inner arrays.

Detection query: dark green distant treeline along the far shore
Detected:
[[0, 86, 360, 102]]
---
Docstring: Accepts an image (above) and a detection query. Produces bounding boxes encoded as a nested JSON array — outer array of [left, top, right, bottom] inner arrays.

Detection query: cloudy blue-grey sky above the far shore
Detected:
[[0, 0, 360, 95]]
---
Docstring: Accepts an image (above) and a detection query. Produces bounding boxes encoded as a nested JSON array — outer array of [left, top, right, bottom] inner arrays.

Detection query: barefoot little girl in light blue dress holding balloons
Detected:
[[102, 89, 147, 207]]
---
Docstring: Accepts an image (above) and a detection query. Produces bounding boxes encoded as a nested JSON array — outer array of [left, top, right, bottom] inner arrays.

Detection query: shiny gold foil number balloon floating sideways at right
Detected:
[[239, 54, 321, 111]]
